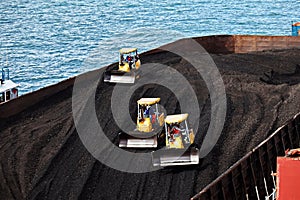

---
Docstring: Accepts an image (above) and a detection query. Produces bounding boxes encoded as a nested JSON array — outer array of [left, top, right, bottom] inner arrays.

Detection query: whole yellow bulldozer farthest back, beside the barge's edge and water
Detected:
[[104, 48, 141, 83]]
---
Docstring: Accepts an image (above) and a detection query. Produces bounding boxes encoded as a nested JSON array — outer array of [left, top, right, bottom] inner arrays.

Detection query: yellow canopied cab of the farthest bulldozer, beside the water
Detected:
[[119, 48, 141, 72]]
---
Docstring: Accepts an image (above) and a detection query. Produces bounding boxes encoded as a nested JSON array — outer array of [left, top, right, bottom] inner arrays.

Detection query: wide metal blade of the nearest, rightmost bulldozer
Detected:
[[151, 147, 199, 167]]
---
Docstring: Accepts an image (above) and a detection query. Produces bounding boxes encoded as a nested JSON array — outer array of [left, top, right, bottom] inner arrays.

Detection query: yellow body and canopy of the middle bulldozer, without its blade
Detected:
[[137, 98, 164, 132]]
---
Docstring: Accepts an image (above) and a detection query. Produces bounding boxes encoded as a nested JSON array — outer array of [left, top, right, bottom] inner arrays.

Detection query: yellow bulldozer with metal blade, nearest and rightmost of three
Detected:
[[152, 114, 199, 166]]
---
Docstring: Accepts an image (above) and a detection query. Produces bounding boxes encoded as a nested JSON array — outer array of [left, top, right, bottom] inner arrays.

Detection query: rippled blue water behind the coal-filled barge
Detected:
[[0, 0, 300, 94]]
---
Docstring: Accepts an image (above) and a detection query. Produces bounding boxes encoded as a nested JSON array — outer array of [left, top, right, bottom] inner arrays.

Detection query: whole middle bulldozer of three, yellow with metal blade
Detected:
[[119, 98, 164, 148]]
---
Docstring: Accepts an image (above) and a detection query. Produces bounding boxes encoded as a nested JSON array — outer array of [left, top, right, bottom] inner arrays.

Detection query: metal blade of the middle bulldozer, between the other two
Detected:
[[119, 133, 157, 148]]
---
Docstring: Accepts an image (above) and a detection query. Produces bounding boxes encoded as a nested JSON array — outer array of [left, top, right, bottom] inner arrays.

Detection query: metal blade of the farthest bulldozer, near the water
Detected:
[[104, 72, 135, 84]]
